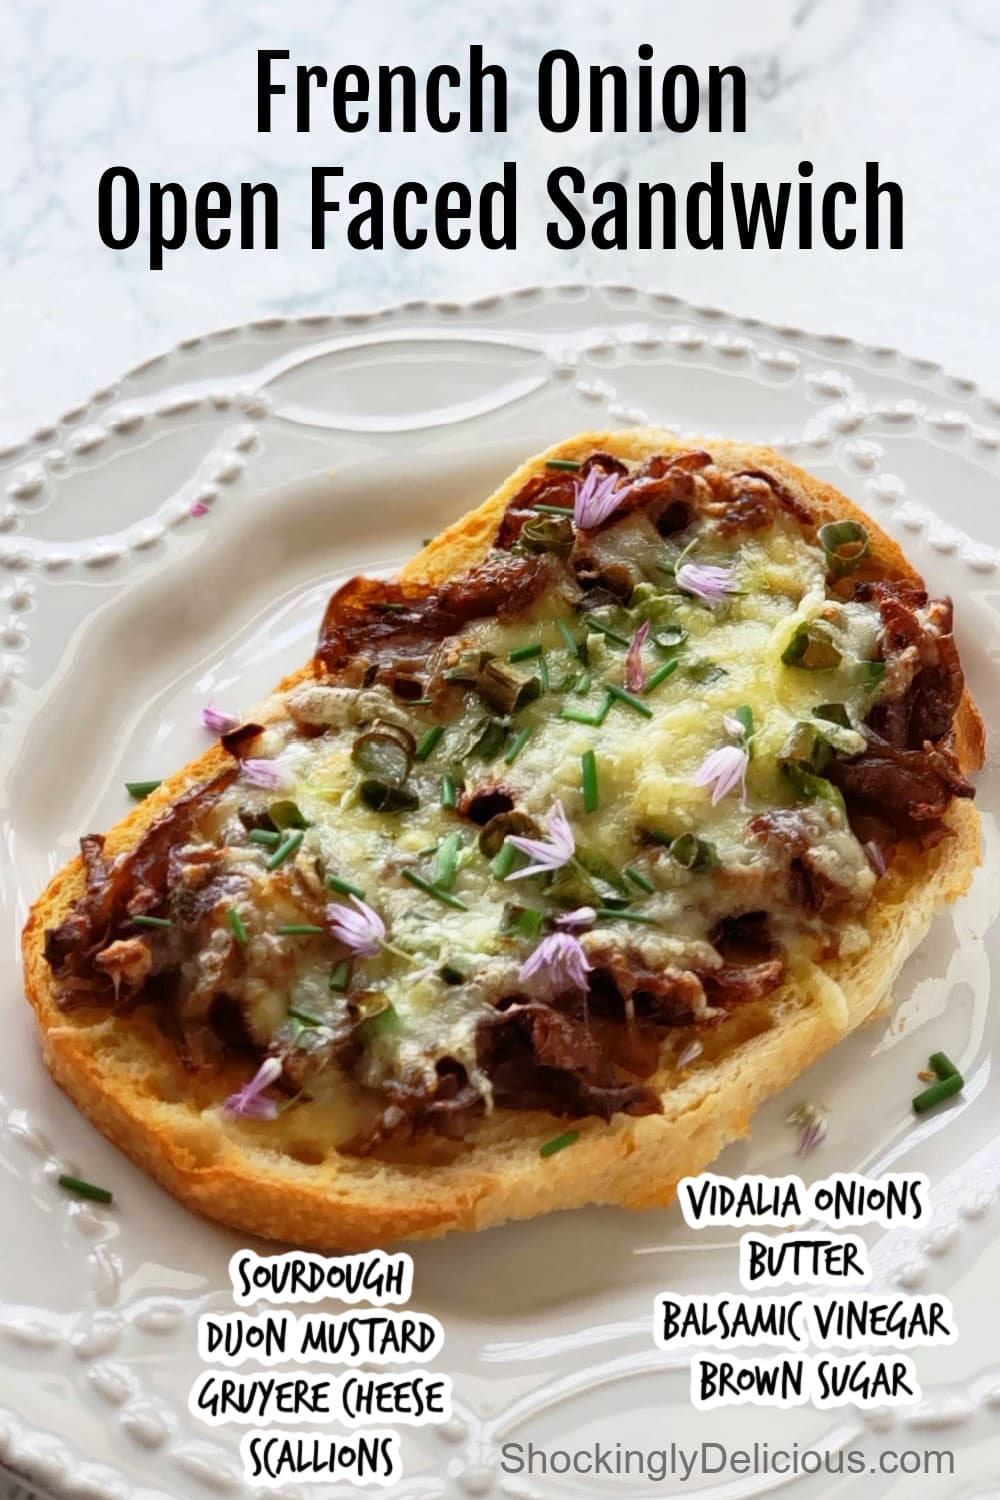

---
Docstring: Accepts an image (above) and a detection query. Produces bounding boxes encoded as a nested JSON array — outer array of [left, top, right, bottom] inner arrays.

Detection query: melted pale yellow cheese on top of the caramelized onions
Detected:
[[199, 515, 880, 1101]]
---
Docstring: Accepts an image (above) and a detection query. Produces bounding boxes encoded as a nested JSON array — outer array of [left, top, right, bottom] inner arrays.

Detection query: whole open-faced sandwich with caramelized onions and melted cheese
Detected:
[[24, 431, 984, 1250]]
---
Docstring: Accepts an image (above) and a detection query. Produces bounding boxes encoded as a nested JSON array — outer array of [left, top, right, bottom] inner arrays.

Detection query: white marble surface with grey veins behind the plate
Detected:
[[0, 0, 1000, 441]]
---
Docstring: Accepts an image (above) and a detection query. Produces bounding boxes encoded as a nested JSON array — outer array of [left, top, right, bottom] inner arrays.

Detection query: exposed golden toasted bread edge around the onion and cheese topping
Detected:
[[24, 429, 985, 1251]]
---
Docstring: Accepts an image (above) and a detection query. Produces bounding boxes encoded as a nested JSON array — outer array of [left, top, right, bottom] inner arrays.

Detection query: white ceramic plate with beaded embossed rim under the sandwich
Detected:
[[0, 287, 1000, 1500]]
